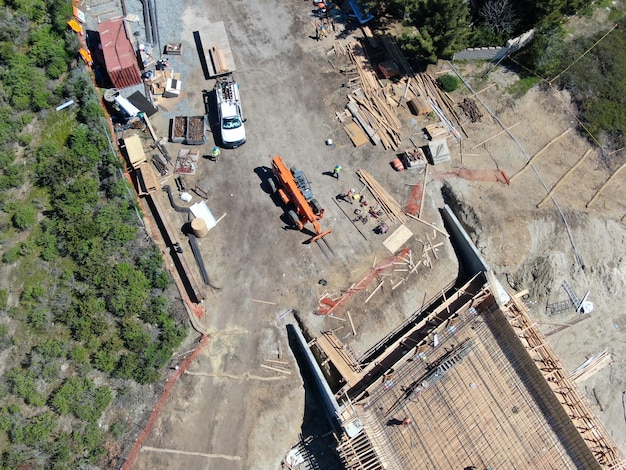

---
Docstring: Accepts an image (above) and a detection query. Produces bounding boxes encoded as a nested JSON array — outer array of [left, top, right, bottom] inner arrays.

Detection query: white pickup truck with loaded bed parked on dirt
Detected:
[[215, 77, 246, 148]]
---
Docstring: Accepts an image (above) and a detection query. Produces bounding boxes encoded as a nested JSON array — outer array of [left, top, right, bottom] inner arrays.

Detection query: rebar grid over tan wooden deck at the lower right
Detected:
[[348, 298, 576, 469]]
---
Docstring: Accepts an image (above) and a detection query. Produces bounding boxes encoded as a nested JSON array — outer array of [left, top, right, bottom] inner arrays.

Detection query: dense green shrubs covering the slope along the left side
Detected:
[[0, 0, 186, 469]]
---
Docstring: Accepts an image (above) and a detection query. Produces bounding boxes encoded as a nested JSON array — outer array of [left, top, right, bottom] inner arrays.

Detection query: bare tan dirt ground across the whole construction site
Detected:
[[128, 0, 626, 470]]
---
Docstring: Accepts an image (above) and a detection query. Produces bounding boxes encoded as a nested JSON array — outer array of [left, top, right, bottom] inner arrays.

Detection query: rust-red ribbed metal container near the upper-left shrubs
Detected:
[[98, 18, 141, 89]]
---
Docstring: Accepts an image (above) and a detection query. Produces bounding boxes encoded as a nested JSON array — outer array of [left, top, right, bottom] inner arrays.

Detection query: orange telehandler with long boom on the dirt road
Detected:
[[268, 156, 332, 246]]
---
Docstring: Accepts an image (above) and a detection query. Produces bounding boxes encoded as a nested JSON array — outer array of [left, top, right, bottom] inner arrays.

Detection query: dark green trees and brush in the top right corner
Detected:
[[367, 0, 626, 153]]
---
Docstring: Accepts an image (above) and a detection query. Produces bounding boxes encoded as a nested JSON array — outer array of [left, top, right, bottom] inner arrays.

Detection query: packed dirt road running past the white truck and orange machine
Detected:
[[136, 1, 450, 469]]
